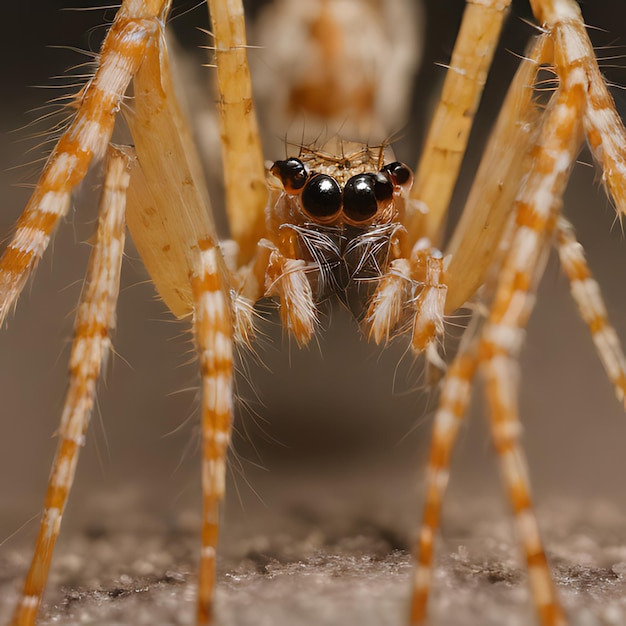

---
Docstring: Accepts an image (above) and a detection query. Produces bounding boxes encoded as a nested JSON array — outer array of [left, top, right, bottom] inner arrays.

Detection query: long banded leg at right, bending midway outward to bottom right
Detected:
[[480, 2, 586, 626]]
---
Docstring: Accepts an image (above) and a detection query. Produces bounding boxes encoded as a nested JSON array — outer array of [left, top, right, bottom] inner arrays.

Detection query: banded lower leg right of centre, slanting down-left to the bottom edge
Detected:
[[410, 344, 477, 626]]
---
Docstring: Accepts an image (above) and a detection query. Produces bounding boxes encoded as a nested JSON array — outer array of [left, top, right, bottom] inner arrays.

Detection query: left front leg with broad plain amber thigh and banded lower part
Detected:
[[118, 18, 240, 624]]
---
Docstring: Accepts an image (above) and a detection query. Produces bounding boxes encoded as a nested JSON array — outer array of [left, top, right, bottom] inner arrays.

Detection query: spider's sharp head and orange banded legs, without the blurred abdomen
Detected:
[[0, 0, 626, 625]]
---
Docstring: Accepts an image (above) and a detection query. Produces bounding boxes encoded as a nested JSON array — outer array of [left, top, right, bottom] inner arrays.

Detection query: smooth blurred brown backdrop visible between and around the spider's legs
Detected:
[[0, 0, 626, 620]]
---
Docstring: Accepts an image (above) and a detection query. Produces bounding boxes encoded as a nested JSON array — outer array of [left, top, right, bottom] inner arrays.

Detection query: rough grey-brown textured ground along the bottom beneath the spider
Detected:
[[0, 478, 626, 626]]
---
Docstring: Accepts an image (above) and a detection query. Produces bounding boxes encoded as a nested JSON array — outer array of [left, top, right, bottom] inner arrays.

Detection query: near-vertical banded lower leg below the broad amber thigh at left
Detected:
[[191, 241, 233, 624]]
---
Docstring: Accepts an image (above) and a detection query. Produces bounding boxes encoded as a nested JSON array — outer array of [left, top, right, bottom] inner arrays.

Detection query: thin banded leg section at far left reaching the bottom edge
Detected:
[[11, 148, 130, 626]]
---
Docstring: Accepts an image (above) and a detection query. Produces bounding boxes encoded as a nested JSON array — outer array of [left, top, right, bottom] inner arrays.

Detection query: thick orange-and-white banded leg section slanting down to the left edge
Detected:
[[0, 0, 170, 323]]
